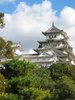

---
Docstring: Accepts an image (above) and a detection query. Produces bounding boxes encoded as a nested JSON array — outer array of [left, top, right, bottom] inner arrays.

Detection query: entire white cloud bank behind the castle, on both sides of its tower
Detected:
[[1, 0, 75, 52]]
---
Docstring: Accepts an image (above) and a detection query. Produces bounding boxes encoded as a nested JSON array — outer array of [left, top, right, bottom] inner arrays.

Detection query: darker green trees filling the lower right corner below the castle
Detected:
[[49, 63, 75, 100]]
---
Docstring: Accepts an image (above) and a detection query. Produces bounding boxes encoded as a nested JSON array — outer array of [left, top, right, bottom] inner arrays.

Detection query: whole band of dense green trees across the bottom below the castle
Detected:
[[0, 60, 75, 100]]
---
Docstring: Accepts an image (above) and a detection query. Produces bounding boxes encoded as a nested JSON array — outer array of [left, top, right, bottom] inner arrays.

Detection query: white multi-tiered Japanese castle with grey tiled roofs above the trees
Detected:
[[22, 23, 75, 66]]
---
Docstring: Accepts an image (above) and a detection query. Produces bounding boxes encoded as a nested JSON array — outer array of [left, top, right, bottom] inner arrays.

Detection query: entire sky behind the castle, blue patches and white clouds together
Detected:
[[0, 0, 75, 53]]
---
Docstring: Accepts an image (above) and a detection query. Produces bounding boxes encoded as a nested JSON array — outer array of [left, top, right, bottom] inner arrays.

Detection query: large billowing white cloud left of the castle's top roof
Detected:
[[1, 1, 54, 49]]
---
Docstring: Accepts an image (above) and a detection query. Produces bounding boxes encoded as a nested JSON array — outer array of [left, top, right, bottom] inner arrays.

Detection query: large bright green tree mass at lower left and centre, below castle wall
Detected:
[[2, 59, 51, 100]]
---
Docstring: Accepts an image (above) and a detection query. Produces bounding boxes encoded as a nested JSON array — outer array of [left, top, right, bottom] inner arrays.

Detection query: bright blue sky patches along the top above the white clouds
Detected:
[[0, 0, 75, 15]]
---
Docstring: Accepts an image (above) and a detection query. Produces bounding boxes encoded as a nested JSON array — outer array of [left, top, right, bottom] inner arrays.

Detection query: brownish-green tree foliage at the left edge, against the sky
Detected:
[[0, 13, 13, 58]]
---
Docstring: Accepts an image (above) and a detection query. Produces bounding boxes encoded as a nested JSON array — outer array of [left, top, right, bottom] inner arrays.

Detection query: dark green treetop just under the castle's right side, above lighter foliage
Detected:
[[49, 63, 73, 80]]
